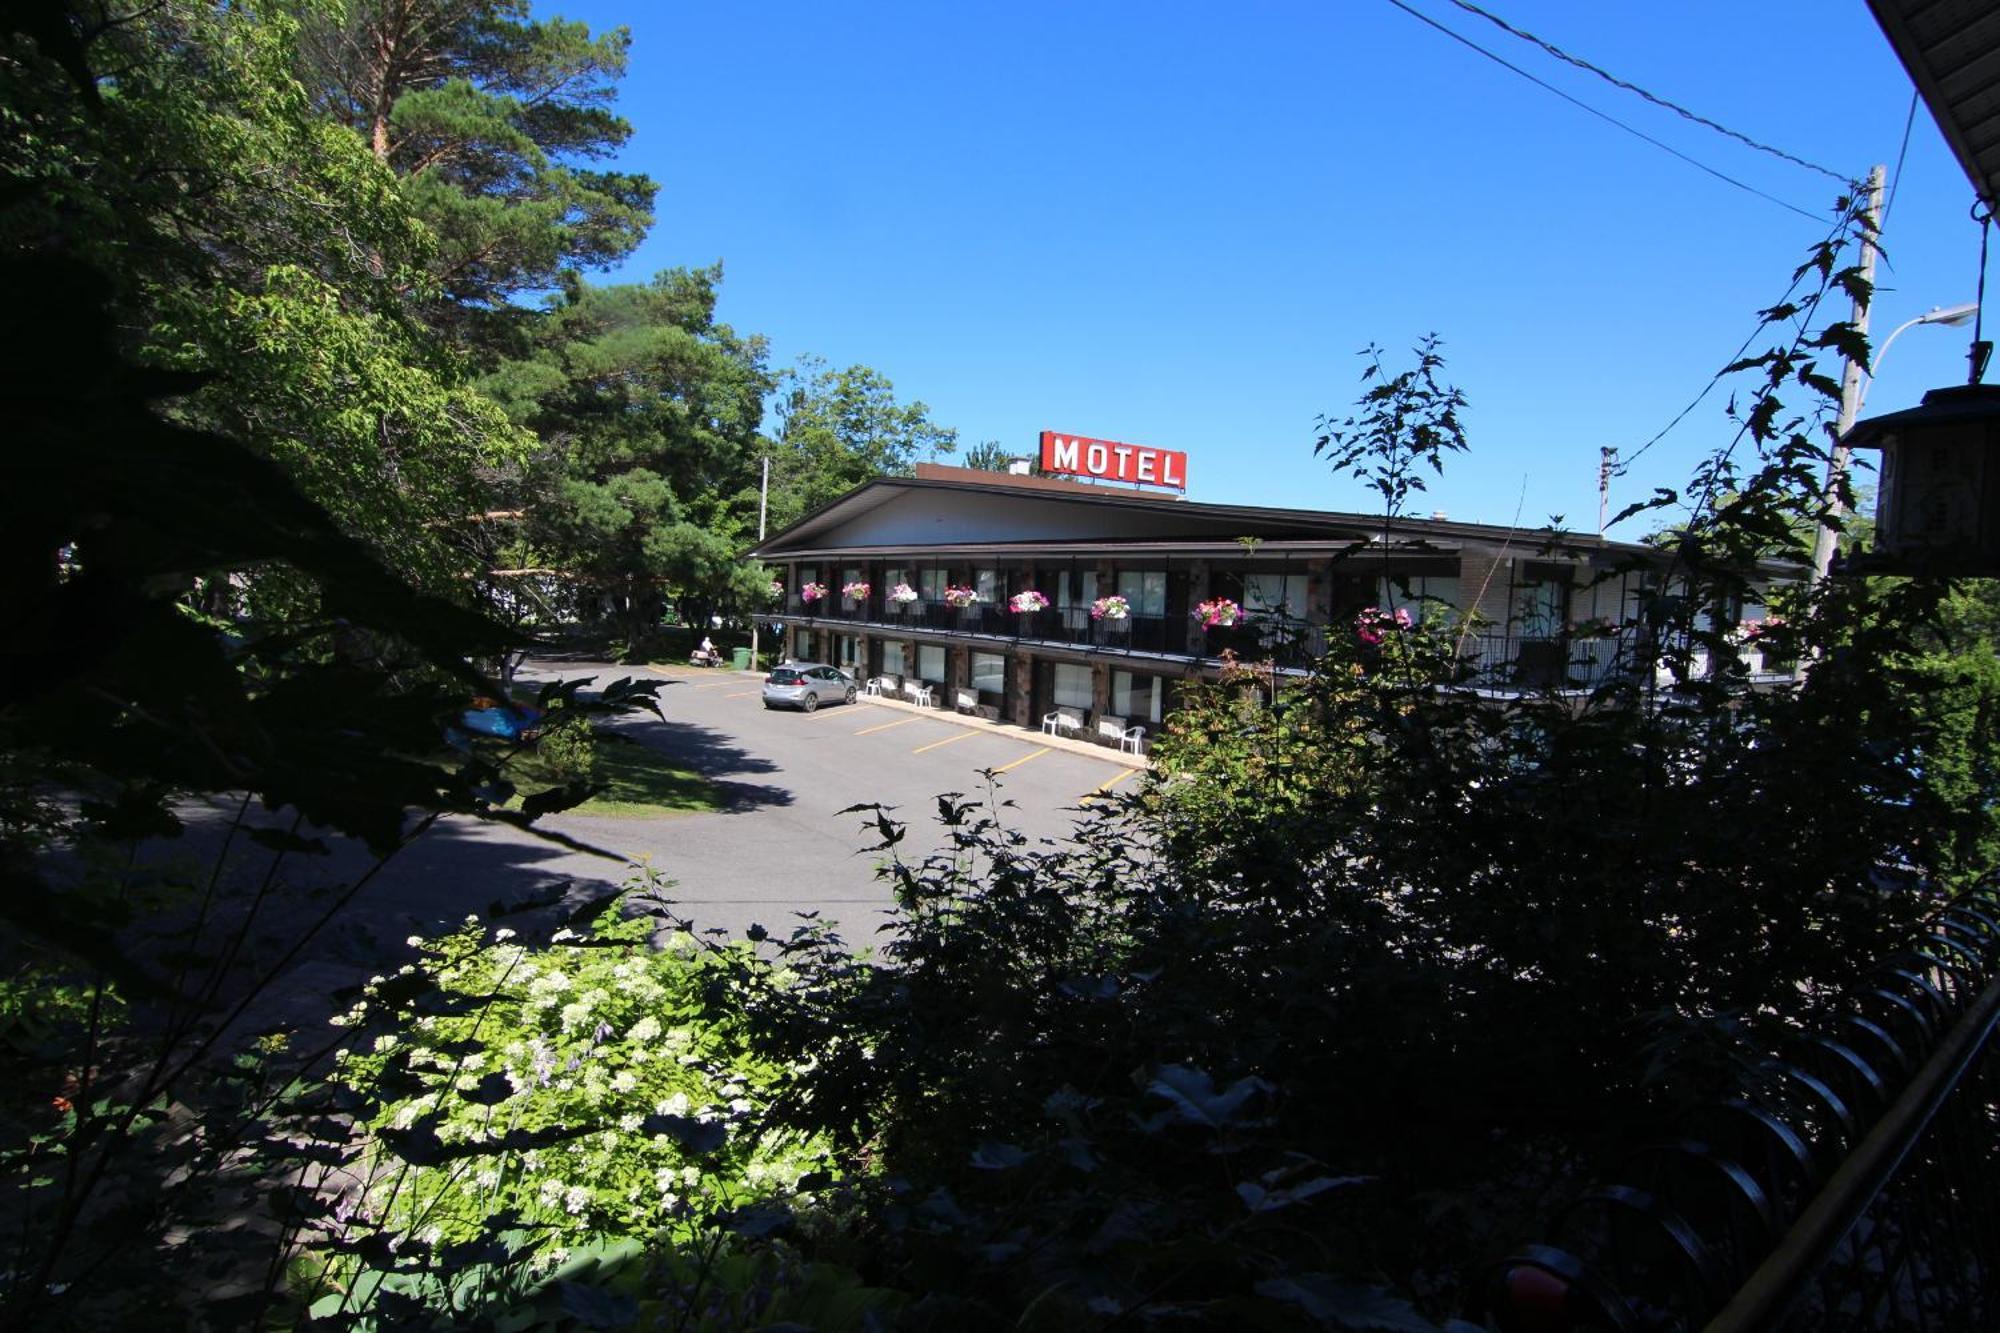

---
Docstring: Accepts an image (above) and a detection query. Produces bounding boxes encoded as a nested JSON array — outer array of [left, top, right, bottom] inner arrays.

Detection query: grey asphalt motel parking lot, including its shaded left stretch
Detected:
[[166, 662, 1136, 1027]]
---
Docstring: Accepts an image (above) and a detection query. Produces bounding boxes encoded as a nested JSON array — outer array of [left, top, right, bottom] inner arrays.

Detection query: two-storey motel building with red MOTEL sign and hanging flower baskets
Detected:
[[750, 432, 1780, 749]]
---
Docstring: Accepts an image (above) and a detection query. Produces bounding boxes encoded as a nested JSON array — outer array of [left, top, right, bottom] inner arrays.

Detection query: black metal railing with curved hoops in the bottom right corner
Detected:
[[1486, 885, 2000, 1333]]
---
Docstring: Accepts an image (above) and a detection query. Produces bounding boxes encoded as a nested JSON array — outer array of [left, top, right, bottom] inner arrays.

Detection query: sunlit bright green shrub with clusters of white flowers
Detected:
[[320, 892, 830, 1261]]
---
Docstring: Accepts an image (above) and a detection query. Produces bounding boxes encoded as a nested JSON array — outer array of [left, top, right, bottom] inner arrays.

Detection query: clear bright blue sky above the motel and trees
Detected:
[[536, 0, 1978, 536]]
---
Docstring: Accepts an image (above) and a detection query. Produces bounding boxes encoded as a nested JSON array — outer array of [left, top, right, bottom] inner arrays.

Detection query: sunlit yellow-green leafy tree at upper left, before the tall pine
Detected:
[[0, 4, 526, 594]]
